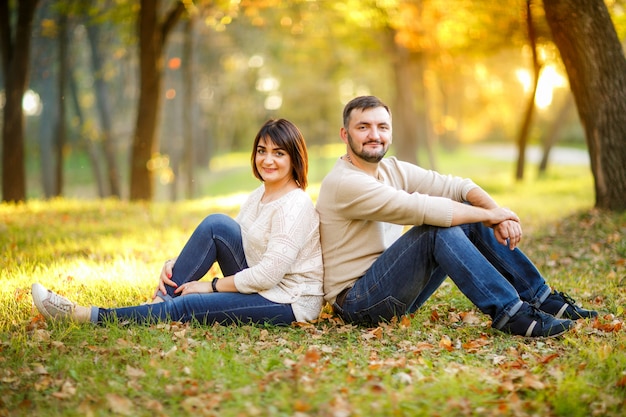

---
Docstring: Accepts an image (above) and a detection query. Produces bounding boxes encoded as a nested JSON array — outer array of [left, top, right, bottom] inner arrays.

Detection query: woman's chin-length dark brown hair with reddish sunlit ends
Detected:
[[250, 119, 309, 190]]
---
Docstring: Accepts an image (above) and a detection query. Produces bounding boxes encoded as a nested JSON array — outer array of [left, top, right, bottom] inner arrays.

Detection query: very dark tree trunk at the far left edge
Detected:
[[0, 0, 39, 202]]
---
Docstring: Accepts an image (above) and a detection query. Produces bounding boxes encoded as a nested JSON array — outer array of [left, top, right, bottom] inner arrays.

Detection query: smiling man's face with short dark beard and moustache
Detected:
[[341, 107, 391, 162]]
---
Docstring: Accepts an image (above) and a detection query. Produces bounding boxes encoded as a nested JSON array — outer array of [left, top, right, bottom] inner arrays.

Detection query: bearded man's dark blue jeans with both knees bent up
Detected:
[[333, 223, 550, 329]]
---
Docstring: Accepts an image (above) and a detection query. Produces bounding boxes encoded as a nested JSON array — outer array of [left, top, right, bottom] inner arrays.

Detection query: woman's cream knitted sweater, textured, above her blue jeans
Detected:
[[235, 185, 324, 321]]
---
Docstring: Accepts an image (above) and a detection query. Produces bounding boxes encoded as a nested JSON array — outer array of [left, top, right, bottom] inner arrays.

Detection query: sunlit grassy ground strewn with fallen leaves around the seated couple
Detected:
[[0, 150, 626, 417]]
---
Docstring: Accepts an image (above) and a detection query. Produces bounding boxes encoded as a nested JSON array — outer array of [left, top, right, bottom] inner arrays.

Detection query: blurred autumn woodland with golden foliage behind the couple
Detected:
[[0, 0, 626, 202]]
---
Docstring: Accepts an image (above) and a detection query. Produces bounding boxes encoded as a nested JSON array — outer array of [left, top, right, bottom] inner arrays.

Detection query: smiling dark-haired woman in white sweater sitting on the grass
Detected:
[[32, 119, 323, 325]]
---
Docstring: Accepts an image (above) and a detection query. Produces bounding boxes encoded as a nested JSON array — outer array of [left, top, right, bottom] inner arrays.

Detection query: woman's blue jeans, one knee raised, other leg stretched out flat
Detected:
[[91, 214, 296, 325]]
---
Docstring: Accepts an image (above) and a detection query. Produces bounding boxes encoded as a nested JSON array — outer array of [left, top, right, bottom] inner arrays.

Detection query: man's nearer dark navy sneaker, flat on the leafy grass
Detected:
[[498, 303, 574, 337]]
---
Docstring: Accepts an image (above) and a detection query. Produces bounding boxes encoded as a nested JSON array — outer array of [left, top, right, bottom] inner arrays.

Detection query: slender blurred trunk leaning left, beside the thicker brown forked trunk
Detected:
[[87, 24, 122, 198]]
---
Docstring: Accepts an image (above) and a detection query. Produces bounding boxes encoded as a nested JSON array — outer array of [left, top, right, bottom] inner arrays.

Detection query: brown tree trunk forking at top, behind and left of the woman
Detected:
[[130, 0, 185, 200]]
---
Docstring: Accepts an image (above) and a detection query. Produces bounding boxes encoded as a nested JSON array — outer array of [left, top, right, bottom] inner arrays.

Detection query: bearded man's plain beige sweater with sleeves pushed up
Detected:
[[317, 157, 477, 304]]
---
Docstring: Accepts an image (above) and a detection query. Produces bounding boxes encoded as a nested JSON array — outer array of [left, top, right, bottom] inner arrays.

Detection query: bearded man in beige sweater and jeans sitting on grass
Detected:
[[317, 96, 597, 337]]
